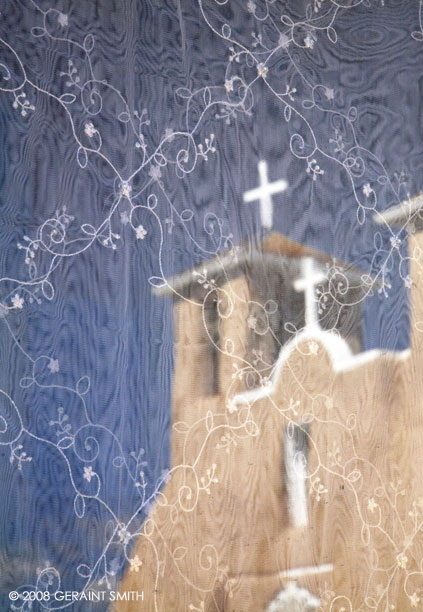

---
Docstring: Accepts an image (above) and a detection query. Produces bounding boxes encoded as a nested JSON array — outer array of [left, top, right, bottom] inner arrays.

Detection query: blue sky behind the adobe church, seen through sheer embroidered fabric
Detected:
[[0, 0, 423, 611]]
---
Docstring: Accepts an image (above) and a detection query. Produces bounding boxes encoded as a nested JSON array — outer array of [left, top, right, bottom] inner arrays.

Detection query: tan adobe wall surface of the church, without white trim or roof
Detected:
[[117, 237, 423, 612]]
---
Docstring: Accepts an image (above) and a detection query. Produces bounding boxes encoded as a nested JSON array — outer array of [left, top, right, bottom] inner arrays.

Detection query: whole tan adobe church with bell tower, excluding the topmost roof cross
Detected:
[[116, 198, 423, 612]]
